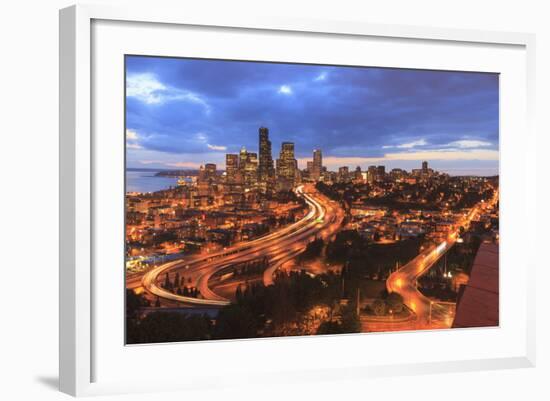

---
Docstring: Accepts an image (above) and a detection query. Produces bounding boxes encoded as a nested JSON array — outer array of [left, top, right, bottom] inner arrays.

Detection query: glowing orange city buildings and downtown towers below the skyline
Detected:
[[126, 127, 498, 268]]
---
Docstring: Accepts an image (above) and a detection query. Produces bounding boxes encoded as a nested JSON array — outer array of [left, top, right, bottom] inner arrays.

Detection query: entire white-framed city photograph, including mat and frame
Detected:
[[60, 6, 535, 395]]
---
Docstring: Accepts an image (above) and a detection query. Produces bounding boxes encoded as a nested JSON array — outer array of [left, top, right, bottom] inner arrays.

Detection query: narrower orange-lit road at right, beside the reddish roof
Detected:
[[386, 190, 498, 329]]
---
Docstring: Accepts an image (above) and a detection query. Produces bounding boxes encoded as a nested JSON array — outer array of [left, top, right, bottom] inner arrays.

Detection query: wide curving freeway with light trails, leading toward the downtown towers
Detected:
[[138, 186, 343, 306]]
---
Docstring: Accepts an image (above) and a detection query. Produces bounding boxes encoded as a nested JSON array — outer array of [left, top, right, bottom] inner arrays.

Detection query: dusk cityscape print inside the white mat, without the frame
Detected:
[[124, 56, 500, 344]]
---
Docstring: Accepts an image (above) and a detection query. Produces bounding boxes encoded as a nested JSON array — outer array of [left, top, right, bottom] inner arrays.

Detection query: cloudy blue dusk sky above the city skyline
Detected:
[[126, 56, 499, 175]]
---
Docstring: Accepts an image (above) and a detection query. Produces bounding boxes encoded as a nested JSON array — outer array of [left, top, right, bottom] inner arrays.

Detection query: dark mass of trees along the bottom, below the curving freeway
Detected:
[[126, 271, 360, 344]]
